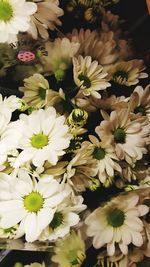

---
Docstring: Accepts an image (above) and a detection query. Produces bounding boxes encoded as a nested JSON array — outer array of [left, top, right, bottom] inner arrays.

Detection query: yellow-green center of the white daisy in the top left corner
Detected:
[[0, 0, 13, 22]]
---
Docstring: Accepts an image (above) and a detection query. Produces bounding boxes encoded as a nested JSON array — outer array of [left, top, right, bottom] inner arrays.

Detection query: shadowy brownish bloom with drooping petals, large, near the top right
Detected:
[[67, 29, 128, 66]]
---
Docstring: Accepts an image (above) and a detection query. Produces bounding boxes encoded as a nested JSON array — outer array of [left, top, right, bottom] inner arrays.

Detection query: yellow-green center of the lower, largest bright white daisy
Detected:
[[24, 192, 44, 212]]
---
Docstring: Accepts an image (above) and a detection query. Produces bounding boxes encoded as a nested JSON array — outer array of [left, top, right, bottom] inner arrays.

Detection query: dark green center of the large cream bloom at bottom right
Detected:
[[107, 208, 125, 227]]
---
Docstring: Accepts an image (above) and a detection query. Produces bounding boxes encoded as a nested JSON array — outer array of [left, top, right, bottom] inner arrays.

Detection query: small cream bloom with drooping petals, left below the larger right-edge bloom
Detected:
[[83, 135, 121, 183]]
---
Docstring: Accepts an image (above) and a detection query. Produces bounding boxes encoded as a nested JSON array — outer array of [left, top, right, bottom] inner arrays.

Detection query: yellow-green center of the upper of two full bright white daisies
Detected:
[[31, 133, 48, 149]]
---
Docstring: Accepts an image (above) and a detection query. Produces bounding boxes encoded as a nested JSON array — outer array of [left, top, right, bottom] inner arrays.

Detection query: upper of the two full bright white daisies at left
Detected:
[[14, 107, 72, 167]]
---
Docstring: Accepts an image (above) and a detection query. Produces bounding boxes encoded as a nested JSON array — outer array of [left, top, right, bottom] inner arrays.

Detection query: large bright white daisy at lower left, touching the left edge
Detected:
[[0, 171, 69, 242]]
